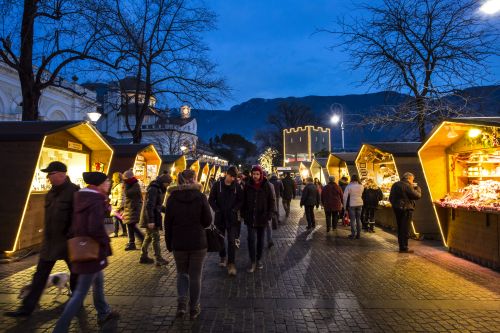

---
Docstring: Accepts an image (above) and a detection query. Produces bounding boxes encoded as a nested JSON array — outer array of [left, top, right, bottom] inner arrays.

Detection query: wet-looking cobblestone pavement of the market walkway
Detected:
[[0, 201, 500, 333]]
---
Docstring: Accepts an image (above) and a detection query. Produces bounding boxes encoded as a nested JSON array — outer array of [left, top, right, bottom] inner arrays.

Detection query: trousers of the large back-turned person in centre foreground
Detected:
[[174, 249, 207, 309]]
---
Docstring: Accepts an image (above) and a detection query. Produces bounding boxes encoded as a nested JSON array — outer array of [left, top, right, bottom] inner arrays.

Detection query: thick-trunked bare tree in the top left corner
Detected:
[[0, 0, 112, 120]]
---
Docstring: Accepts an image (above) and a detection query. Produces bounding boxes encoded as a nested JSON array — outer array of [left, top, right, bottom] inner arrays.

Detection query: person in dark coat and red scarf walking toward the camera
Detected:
[[241, 165, 276, 273]]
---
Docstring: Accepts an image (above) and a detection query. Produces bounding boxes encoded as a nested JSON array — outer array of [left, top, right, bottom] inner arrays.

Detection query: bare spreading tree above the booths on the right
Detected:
[[323, 0, 498, 140]]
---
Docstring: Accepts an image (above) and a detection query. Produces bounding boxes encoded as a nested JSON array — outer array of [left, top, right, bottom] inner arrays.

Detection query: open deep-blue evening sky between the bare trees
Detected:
[[206, 0, 500, 109]]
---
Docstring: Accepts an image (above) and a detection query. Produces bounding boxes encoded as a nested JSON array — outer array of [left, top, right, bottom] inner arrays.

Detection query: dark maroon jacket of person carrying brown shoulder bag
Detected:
[[71, 188, 111, 274]]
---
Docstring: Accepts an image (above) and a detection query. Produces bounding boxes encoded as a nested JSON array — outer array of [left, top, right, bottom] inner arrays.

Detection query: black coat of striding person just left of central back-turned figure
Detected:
[[140, 180, 166, 229]]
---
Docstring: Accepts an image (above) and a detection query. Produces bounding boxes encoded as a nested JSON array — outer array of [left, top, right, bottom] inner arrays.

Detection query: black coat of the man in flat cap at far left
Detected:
[[40, 178, 80, 261]]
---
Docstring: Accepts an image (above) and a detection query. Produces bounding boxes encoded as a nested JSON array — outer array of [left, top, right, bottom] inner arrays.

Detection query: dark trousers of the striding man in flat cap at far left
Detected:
[[22, 258, 78, 312]]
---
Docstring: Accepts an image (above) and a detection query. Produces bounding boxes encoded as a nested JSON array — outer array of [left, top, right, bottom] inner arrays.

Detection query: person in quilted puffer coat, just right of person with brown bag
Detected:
[[123, 170, 144, 251]]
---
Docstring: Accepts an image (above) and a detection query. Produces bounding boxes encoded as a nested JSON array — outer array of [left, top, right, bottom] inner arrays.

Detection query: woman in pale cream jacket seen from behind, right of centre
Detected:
[[344, 175, 364, 239]]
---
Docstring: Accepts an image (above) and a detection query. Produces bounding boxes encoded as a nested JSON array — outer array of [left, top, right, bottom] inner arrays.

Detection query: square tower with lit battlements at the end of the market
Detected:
[[283, 126, 331, 166]]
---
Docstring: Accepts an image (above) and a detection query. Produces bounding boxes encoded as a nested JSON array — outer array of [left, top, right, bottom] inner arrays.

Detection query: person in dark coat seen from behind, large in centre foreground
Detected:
[[164, 169, 212, 319]]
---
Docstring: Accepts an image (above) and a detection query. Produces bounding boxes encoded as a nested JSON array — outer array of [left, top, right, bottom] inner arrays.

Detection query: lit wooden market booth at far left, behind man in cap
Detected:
[[0, 121, 113, 254]]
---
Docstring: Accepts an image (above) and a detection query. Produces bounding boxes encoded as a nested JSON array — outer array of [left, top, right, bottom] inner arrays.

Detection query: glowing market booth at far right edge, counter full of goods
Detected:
[[418, 118, 500, 269]]
